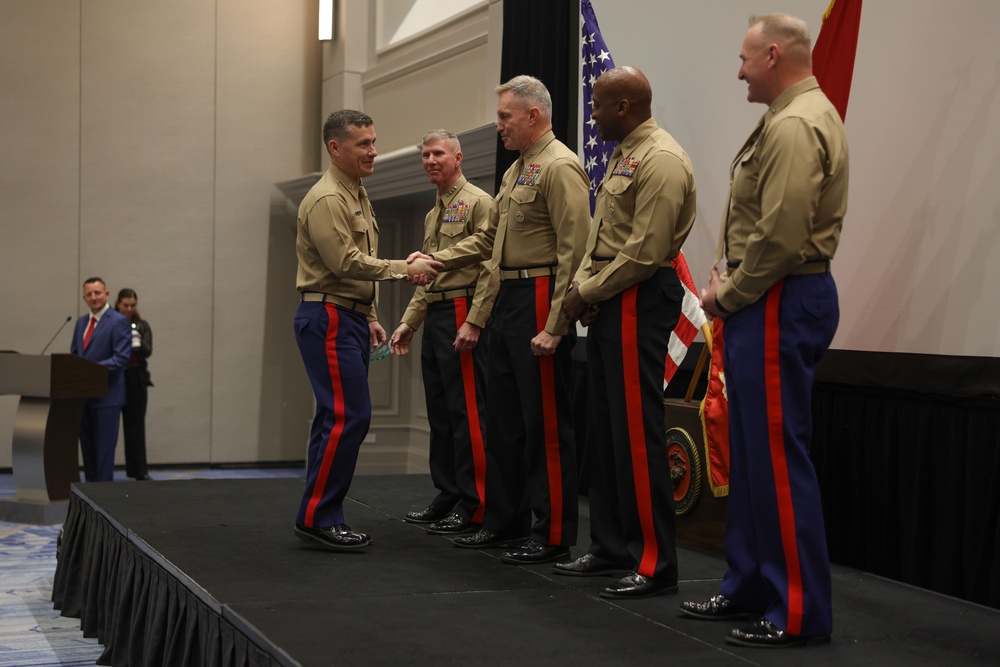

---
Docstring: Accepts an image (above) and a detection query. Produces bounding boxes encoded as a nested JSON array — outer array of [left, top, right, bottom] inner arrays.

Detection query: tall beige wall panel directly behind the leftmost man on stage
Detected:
[[212, 0, 321, 463]]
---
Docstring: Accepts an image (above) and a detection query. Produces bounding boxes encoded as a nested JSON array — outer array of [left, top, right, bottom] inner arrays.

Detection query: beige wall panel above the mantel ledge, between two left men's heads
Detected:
[[365, 44, 496, 153]]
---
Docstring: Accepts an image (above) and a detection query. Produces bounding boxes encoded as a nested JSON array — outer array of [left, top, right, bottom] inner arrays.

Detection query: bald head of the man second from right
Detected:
[[591, 65, 653, 141]]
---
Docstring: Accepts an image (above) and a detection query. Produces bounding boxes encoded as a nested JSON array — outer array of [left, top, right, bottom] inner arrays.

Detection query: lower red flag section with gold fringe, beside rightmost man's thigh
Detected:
[[699, 319, 729, 498]]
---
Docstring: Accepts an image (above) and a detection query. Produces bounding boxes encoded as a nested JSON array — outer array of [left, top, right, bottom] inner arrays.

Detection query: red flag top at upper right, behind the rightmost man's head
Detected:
[[813, 0, 861, 120]]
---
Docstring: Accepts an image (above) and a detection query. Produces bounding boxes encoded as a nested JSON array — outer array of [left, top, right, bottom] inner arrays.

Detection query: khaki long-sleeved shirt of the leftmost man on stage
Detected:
[[295, 164, 406, 320]]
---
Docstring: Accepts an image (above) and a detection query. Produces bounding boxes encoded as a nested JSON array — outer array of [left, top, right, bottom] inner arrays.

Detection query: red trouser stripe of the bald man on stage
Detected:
[[622, 285, 660, 577]]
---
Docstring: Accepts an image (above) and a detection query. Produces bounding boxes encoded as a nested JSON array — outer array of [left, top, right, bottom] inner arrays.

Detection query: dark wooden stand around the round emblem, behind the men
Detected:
[[663, 398, 727, 553]]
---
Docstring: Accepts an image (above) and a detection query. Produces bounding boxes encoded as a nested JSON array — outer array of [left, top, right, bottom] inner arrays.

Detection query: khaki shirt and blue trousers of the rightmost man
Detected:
[[716, 77, 848, 637]]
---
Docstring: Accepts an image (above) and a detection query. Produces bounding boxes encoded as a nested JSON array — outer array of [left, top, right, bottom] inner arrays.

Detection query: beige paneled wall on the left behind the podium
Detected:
[[0, 0, 320, 467]]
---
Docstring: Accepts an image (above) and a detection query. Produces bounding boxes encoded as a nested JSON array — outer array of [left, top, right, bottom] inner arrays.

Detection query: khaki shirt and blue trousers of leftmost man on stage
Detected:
[[295, 160, 406, 528]]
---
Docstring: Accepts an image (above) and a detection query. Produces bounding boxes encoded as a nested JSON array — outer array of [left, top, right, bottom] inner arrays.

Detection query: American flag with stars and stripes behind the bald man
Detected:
[[580, 0, 708, 388]]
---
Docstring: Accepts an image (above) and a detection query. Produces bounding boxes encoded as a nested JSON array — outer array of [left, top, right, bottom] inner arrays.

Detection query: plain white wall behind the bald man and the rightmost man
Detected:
[[592, 0, 1000, 357]]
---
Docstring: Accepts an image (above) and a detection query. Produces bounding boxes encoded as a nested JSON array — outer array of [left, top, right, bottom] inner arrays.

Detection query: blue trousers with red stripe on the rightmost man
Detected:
[[720, 273, 840, 637]]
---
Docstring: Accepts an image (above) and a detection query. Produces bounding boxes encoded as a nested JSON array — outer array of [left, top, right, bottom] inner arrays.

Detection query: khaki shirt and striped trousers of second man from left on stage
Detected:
[[394, 176, 498, 523]]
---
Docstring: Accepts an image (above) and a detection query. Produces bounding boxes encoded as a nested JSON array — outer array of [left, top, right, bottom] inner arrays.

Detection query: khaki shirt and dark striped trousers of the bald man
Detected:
[[576, 118, 695, 583]]
